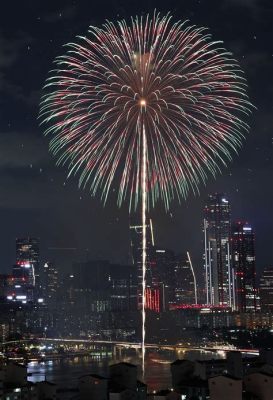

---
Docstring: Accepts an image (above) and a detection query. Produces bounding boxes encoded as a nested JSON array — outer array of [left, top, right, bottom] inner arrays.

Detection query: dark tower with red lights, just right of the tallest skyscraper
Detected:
[[232, 221, 257, 312]]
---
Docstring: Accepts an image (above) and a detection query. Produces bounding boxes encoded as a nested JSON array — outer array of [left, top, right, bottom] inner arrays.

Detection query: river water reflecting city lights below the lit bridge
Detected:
[[28, 348, 223, 391]]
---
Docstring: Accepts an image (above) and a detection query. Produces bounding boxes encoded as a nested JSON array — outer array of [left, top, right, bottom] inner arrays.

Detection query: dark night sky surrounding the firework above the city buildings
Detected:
[[0, 0, 273, 272]]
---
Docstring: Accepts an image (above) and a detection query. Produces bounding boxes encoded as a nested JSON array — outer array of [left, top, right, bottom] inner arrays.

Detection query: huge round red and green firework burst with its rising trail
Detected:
[[39, 13, 252, 376]]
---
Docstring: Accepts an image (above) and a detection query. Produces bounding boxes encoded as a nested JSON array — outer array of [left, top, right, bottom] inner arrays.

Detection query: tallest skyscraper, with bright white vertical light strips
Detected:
[[204, 193, 235, 308]]
